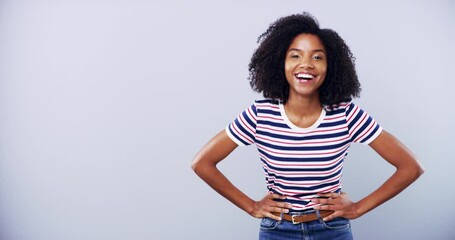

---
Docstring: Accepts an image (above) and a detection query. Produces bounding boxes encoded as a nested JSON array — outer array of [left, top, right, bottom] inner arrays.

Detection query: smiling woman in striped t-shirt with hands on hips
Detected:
[[192, 13, 423, 239]]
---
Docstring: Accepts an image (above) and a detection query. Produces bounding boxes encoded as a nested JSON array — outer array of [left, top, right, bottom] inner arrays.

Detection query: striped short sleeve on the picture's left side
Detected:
[[226, 104, 257, 146]]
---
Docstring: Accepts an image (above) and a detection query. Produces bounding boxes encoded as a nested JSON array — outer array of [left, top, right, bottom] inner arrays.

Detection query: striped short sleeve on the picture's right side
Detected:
[[346, 102, 382, 144]]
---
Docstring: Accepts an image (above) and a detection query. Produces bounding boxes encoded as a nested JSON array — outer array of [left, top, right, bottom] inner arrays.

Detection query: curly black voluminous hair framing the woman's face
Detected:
[[248, 12, 361, 106]]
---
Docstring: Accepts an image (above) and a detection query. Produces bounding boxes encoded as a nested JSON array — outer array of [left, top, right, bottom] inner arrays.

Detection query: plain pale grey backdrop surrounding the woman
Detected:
[[0, 0, 455, 240]]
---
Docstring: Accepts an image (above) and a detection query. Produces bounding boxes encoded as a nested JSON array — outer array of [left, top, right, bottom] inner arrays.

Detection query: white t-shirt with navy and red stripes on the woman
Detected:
[[226, 99, 382, 211]]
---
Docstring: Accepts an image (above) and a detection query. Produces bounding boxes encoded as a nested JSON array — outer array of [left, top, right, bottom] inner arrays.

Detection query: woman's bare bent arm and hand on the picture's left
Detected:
[[191, 130, 291, 220]]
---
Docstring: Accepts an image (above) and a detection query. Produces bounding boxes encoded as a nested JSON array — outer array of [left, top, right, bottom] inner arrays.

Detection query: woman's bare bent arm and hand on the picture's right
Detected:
[[314, 130, 424, 221]]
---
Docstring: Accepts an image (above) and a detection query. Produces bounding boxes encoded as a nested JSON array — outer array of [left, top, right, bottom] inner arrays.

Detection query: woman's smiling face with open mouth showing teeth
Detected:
[[284, 33, 327, 99]]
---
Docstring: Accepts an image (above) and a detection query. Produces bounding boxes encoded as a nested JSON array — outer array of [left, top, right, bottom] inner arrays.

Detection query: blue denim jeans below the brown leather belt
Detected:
[[259, 211, 353, 240]]
